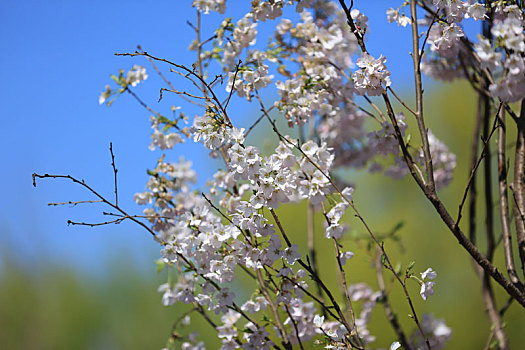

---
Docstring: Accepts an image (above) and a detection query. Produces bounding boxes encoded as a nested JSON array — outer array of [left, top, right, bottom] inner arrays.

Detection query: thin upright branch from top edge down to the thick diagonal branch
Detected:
[[410, 0, 436, 192]]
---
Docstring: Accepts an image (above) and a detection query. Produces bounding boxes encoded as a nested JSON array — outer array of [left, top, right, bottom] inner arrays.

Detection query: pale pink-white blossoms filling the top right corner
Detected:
[[408, 0, 525, 102]]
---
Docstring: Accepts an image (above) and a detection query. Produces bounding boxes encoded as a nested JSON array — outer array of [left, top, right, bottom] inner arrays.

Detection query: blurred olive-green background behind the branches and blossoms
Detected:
[[4, 83, 525, 349]]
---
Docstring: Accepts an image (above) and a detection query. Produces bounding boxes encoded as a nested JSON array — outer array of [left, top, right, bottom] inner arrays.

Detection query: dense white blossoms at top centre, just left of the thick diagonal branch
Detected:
[[276, 7, 358, 125]]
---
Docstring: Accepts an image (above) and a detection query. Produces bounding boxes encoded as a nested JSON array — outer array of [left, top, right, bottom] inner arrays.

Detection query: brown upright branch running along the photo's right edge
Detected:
[[513, 99, 525, 276]]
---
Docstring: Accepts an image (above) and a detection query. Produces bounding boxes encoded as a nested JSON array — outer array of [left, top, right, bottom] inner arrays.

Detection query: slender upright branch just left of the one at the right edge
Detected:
[[497, 108, 520, 284]]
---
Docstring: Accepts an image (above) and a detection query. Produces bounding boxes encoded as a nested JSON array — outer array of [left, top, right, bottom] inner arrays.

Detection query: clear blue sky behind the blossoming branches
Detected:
[[0, 0, 426, 274]]
